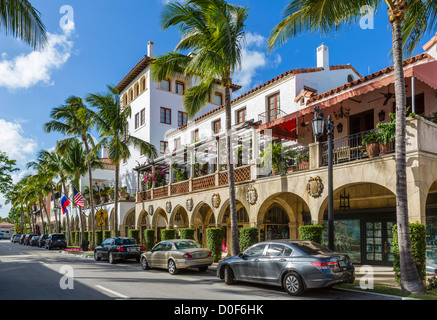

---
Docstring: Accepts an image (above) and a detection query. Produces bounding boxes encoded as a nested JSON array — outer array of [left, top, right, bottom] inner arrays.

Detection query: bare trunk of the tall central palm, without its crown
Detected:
[[225, 85, 240, 256]]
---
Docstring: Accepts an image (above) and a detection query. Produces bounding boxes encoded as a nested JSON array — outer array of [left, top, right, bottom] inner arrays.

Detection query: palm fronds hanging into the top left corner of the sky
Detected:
[[0, 0, 47, 49]]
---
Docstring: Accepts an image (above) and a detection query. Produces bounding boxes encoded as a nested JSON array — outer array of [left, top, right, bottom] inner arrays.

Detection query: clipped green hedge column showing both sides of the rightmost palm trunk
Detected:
[[393, 222, 426, 284]]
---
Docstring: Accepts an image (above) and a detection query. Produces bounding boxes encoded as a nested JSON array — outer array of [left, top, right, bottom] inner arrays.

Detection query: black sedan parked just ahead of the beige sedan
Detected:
[[94, 238, 146, 264]]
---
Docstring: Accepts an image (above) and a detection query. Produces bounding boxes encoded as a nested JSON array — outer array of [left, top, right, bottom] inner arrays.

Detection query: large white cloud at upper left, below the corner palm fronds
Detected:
[[0, 29, 73, 91]]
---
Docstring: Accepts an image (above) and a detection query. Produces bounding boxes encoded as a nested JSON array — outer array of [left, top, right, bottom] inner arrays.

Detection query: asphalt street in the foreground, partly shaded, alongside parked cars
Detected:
[[0, 240, 398, 303]]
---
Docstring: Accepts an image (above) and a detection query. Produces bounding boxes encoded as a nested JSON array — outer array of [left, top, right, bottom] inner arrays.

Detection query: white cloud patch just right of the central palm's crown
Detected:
[[233, 32, 282, 94]]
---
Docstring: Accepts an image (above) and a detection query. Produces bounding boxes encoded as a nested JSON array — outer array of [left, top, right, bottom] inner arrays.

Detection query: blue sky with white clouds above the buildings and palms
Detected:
[[0, 0, 431, 217]]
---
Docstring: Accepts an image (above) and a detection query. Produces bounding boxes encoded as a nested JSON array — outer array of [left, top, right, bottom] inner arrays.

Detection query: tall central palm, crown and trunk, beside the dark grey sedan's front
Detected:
[[152, 0, 248, 255]]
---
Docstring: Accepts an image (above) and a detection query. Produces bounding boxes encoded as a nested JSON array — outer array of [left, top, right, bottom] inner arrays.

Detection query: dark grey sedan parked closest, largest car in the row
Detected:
[[217, 240, 355, 296]]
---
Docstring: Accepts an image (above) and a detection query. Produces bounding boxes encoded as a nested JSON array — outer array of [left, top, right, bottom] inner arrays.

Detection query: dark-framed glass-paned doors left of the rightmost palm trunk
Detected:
[[363, 221, 395, 266]]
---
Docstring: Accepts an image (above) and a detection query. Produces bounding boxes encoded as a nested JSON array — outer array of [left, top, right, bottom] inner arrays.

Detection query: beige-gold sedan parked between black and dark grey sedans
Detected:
[[141, 240, 214, 275]]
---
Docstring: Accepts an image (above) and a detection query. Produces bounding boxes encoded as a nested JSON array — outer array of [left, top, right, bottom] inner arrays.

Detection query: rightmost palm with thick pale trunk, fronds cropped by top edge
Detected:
[[268, 0, 430, 293]]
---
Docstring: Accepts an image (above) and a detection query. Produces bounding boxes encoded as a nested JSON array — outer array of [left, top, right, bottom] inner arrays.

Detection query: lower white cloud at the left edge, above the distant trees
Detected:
[[0, 119, 38, 165]]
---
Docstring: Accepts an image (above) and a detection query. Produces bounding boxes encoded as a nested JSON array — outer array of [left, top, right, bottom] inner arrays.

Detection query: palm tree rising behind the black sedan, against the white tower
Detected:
[[87, 86, 157, 237]]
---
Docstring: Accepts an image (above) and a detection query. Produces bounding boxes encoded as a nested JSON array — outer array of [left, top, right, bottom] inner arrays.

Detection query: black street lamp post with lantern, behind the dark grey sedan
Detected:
[[313, 107, 334, 251]]
